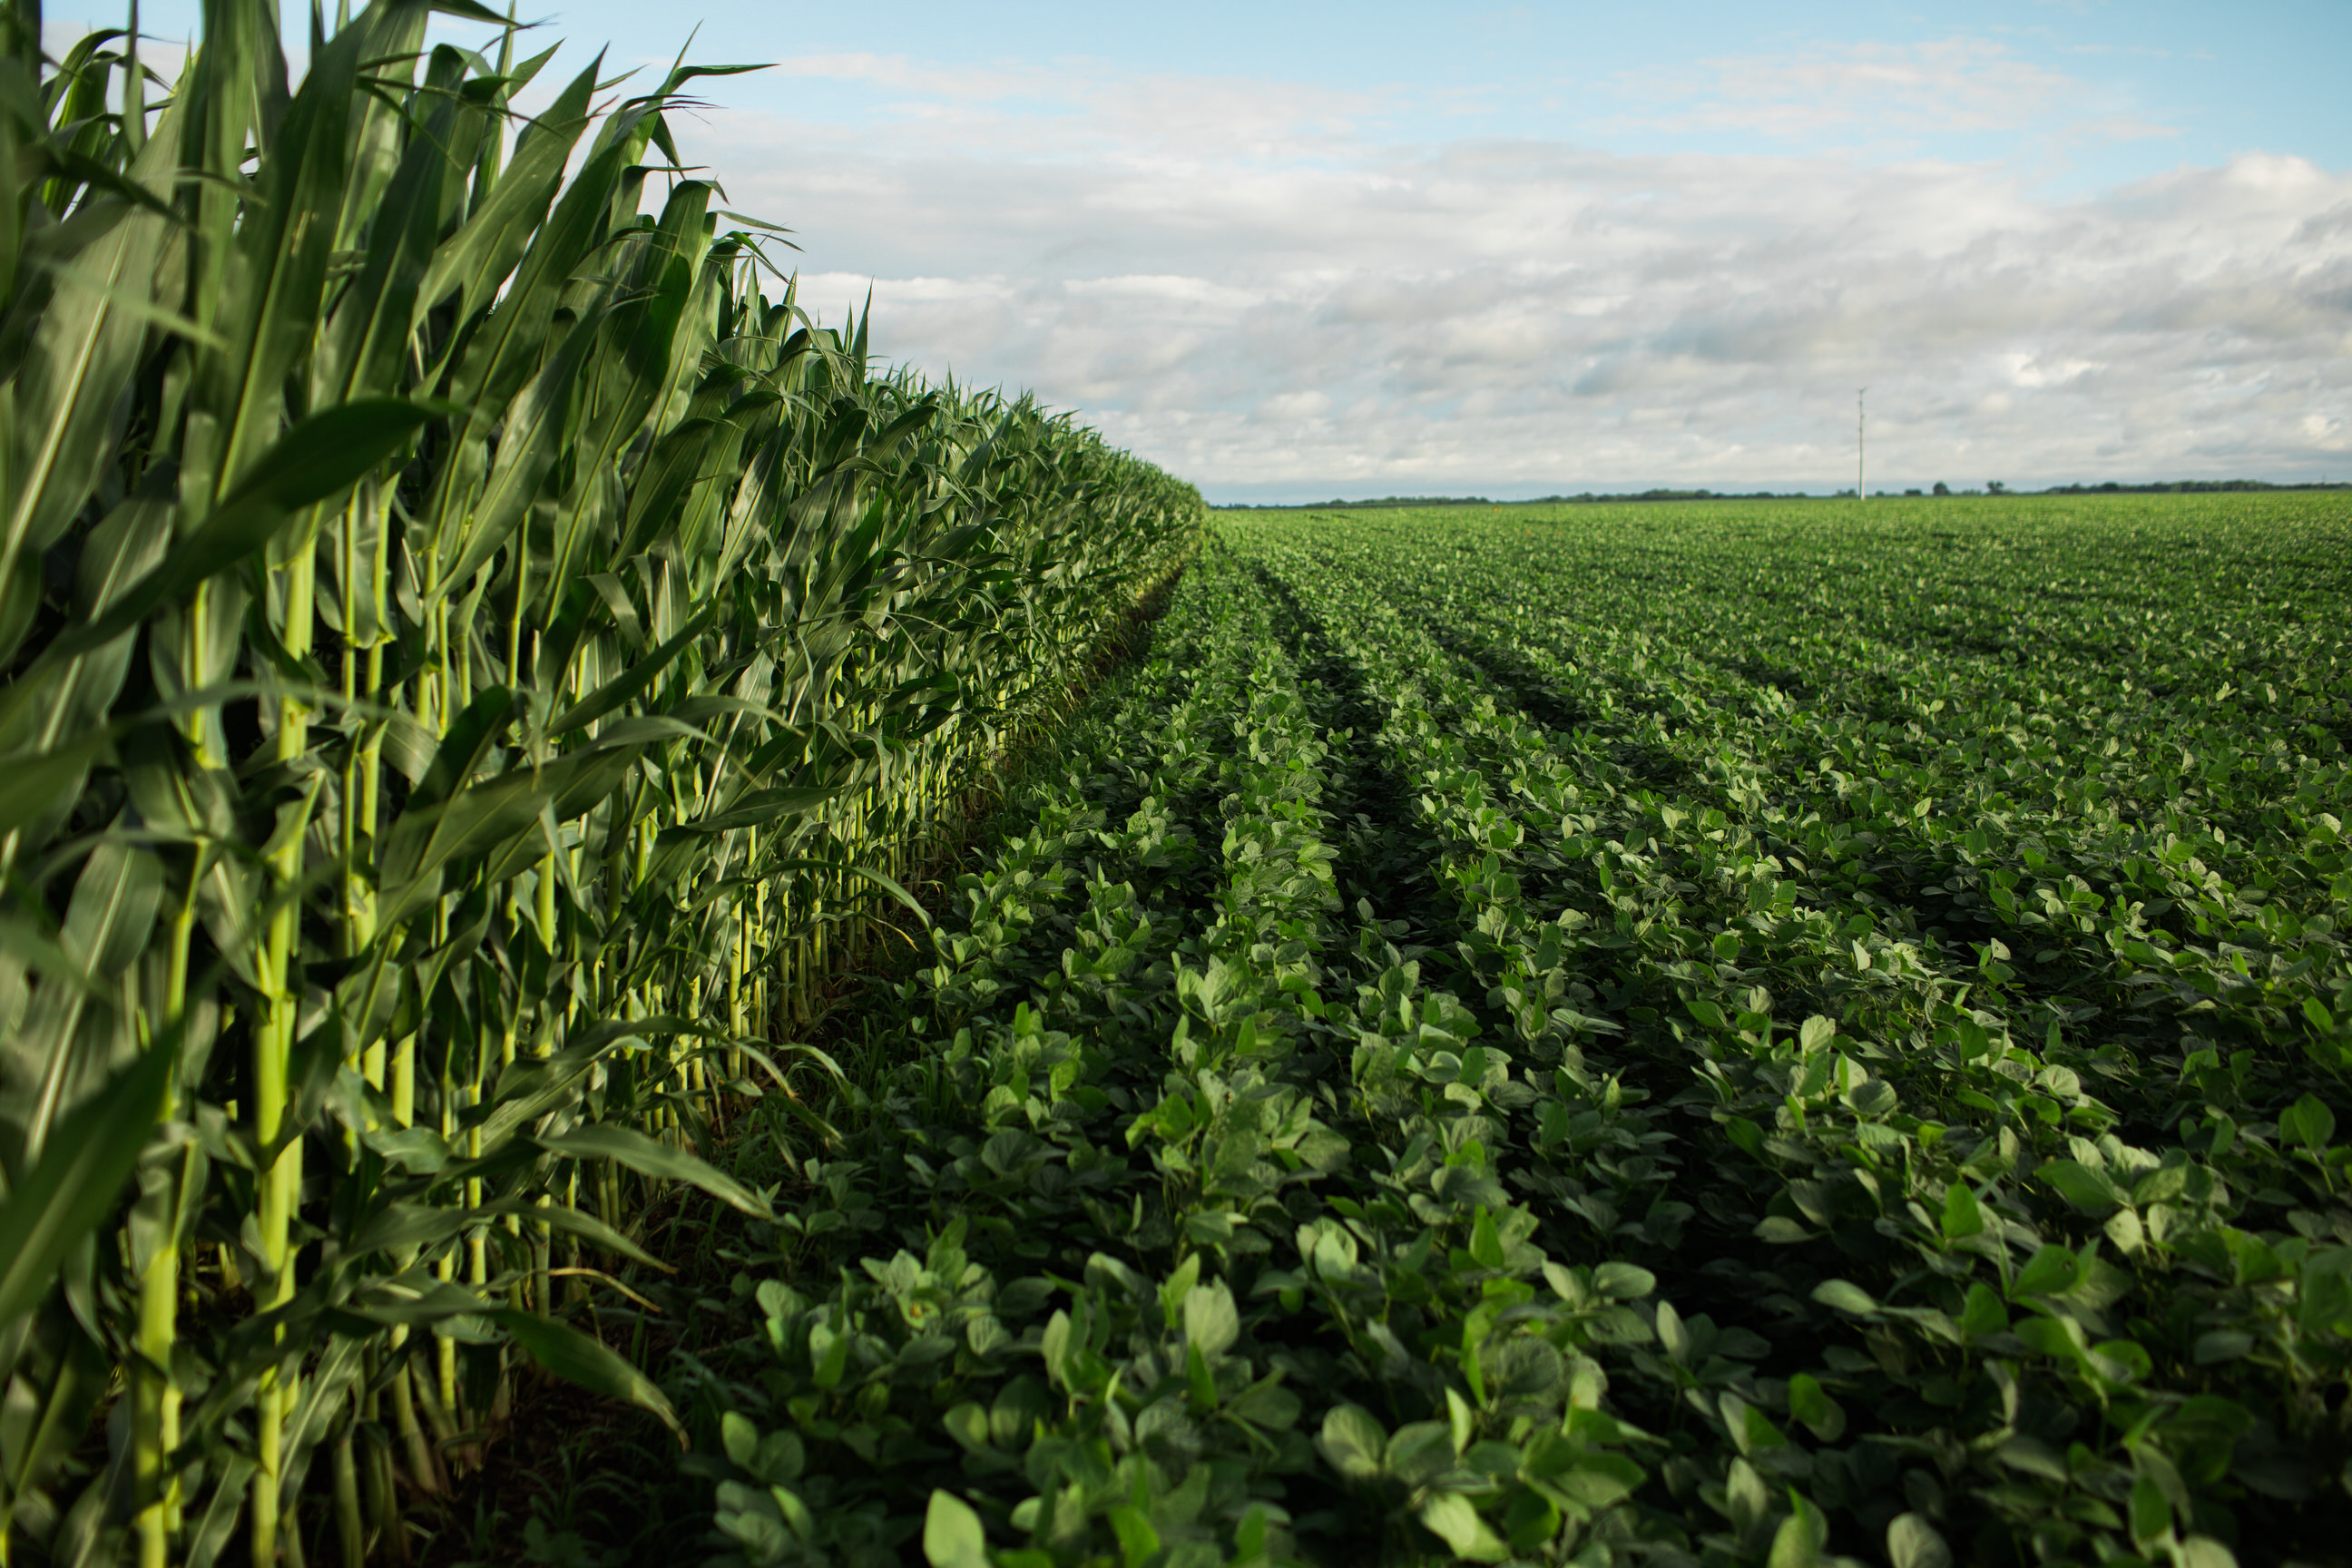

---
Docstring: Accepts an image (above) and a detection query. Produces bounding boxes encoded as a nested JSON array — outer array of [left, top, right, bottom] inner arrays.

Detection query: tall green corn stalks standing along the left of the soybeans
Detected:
[[0, 0, 1200, 1565]]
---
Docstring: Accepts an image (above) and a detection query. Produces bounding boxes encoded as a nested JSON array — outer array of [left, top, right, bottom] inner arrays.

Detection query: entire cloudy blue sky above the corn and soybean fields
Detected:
[[44, 0, 2352, 501]]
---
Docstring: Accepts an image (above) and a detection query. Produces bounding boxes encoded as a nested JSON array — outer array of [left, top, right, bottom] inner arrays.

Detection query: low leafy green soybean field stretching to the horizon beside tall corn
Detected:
[[663, 496, 2352, 1568]]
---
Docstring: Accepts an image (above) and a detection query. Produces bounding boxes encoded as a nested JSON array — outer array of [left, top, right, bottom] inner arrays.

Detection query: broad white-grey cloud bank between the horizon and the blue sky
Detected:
[[699, 54, 2352, 494]]
